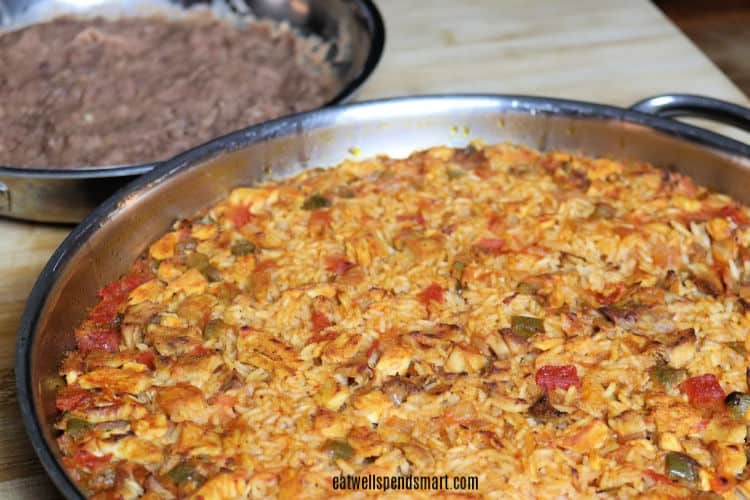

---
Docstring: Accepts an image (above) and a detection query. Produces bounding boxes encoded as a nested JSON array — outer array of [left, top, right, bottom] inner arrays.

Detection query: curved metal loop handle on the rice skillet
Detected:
[[630, 94, 750, 132]]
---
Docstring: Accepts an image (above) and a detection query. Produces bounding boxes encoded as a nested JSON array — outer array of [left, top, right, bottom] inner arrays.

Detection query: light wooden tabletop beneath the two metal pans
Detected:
[[0, 0, 748, 499]]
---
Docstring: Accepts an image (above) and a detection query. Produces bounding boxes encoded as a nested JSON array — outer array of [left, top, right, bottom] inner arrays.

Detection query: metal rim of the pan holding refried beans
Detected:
[[0, 0, 386, 180]]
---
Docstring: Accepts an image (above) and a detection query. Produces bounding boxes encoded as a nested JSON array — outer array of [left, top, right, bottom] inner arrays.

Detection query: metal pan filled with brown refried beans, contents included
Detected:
[[0, 0, 384, 222]]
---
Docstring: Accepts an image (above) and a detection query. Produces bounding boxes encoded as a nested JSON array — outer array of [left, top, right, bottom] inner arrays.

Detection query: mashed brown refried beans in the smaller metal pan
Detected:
[[0, 13, 336, 168]]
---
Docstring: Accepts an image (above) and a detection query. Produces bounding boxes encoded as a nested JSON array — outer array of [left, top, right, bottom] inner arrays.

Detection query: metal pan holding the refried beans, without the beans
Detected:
[[0, 0, 385, 223]]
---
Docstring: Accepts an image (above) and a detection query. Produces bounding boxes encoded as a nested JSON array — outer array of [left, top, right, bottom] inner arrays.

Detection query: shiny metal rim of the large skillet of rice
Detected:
[[15, 94, 750, 500]]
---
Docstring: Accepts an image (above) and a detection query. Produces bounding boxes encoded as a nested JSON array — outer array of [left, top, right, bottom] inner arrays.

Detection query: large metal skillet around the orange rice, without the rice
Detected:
[[16, 95, 750, 499]]
